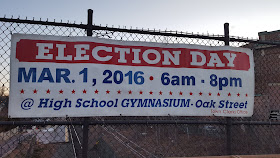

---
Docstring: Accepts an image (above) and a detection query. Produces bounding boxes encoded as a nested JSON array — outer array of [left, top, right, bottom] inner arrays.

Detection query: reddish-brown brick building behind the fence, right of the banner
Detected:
[[250, 30, 280, 120]]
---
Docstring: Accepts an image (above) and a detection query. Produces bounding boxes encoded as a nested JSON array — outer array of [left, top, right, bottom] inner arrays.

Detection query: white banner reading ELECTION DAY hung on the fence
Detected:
[[9, 34, 254, 117]]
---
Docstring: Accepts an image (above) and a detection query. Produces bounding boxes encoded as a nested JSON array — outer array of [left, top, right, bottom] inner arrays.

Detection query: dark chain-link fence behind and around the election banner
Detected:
[[0, 10, 280, 158]]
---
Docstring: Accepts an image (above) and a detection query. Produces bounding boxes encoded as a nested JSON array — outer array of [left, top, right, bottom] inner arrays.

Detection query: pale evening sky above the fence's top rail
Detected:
[[0, 0, 280, 39]]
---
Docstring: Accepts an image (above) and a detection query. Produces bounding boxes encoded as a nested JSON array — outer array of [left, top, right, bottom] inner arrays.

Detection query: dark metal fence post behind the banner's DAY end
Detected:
[[224, 23, 232, 155]]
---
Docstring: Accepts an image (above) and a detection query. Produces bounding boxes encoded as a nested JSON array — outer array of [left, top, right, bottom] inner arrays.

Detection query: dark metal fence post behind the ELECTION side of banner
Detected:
[[82, 9, 93, 158]]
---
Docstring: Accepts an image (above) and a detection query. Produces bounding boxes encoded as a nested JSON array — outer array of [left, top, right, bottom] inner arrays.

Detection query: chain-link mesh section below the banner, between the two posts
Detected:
[[86, 124, 225, 157]]
